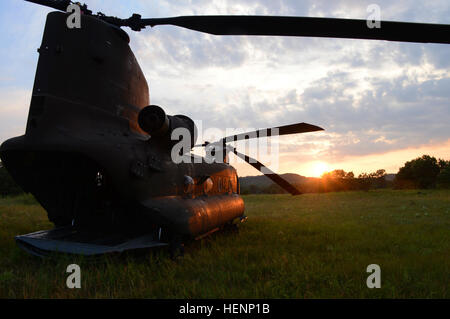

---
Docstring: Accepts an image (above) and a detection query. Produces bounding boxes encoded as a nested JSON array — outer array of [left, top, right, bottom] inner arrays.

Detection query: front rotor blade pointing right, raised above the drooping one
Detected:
[[222, 123, 324, 143]]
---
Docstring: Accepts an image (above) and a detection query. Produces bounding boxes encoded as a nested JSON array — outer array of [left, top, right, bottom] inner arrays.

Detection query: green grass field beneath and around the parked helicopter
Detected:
[[0, 190, 450, 298]]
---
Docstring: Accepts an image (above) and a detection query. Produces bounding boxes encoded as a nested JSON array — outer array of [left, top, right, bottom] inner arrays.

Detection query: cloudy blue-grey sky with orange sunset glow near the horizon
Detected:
[[0, 0, 450, 176]]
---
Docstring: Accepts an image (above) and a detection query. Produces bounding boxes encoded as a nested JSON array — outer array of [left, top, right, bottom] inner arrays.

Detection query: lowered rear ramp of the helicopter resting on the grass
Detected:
[[15, 226, 168, 257]]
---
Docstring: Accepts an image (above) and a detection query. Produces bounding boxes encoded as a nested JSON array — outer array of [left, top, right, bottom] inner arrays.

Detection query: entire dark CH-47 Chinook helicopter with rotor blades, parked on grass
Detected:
[[0, 0, 450, 255]]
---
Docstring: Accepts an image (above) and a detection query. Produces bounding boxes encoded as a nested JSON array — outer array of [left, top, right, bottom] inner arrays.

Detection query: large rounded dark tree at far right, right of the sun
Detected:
[[395, 155, 440, 188]]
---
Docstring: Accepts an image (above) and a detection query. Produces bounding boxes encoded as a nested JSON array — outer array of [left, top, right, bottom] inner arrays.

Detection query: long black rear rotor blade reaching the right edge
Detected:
[[140, 16, 450, 43]]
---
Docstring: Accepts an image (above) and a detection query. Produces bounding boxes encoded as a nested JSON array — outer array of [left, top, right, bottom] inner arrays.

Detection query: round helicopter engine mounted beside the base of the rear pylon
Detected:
[[138, 105, 197, 148]]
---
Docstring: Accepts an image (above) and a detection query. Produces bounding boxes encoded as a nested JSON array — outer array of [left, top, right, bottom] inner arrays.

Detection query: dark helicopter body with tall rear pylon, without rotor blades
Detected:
[[0, 12, 244, 242]]
